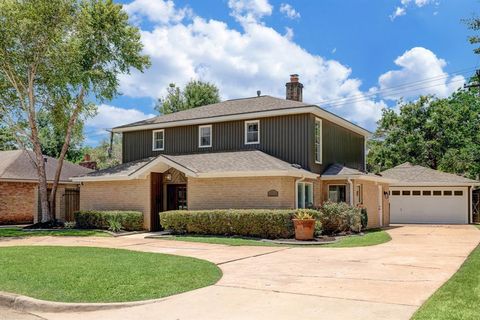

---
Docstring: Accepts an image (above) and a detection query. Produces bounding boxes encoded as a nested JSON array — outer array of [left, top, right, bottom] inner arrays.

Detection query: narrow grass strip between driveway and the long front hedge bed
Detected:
[[158, 229, 392, 248]]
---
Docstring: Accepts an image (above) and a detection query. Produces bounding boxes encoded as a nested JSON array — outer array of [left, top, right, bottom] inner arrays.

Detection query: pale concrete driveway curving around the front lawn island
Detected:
[[0, 225, 480, 320]]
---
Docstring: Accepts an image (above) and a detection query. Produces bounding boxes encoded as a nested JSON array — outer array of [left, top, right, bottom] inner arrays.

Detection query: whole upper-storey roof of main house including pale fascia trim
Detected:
[[113, 96, 370, 136]]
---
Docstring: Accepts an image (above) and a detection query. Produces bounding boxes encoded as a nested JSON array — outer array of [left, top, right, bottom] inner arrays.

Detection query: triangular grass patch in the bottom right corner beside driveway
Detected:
[[412, 244, 480, 320]]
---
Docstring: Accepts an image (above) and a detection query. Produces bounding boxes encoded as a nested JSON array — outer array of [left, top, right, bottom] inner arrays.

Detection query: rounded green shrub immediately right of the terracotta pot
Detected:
[[320, 202, 361, 234]]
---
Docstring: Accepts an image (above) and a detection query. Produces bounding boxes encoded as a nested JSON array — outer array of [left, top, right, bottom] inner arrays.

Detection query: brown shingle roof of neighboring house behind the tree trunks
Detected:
[[0, 150, 92, 182]]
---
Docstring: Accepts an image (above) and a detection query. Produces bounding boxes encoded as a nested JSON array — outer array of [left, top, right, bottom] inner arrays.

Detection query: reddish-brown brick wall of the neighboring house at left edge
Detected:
[[0, 182, 37, 224]]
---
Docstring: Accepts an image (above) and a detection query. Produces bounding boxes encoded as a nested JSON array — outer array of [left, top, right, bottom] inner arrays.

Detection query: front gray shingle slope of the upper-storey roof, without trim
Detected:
[[114, 96, 311, 129]]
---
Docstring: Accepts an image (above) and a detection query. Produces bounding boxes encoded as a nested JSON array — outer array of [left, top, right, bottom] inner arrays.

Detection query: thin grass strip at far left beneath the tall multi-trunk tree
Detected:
[[0, 228, 110, 238]]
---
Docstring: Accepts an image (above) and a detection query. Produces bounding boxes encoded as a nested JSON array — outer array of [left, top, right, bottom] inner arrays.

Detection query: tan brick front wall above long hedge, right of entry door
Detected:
[[187, 177, 296, 210]]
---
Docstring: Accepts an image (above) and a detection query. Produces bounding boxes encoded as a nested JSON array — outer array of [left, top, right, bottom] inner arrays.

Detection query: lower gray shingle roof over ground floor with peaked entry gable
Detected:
[[78, 150, 313, 179]]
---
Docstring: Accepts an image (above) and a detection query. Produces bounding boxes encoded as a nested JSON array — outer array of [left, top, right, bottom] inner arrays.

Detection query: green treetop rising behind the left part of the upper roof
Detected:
[[155, 80, 220, 114]]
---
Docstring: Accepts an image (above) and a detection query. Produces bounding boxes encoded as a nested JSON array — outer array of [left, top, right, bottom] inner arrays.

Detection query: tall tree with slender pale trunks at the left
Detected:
[[0, 0, 149, 222]]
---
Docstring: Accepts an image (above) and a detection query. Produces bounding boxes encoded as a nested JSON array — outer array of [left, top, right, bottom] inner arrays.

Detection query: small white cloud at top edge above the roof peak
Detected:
[[228, 0, 273, 23]]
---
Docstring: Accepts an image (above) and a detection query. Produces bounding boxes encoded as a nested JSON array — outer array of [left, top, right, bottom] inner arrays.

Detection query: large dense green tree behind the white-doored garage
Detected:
[[367, 90, 480, 178]]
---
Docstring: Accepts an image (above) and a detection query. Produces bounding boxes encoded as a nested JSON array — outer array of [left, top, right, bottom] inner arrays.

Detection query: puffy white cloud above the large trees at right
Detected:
[[378, 47, 465, 100]]
